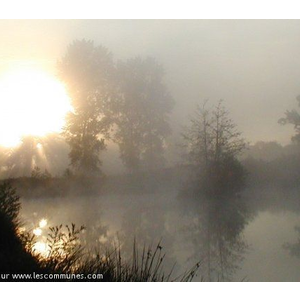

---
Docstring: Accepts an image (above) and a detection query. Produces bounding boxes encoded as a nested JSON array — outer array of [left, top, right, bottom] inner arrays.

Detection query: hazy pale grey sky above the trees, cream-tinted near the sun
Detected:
[[0, 20, 300, 143]]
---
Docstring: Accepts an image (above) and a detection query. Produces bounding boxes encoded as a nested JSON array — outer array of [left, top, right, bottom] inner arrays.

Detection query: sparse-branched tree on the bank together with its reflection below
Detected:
[[180, 102, 249, 281]]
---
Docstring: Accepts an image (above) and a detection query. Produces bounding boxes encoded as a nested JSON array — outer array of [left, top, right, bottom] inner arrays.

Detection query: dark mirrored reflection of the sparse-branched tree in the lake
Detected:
[[188, 192, 249, 281]]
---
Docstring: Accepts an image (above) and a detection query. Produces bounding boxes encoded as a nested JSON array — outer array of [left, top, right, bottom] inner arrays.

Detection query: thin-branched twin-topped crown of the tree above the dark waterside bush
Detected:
[[183, 100, 246, 167]]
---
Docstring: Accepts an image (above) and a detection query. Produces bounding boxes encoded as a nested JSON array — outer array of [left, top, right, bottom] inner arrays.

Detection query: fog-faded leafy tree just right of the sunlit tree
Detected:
[[114, 57, 174, 172]]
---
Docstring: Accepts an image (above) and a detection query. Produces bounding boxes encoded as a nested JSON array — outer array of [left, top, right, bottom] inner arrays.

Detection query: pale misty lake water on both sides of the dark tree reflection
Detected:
[[18, 191, 300, 281]]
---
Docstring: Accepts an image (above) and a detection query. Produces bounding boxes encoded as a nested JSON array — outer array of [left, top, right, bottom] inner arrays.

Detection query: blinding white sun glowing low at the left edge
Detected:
[[0, 67, 71, 147]]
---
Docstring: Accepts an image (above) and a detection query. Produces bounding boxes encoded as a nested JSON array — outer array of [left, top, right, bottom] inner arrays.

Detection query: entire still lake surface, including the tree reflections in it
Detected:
[[22, 191, 300, 281]]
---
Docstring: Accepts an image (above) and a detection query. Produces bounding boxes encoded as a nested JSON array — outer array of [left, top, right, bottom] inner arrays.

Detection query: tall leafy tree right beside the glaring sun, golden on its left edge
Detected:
[[58, 40, 114, 175]]
